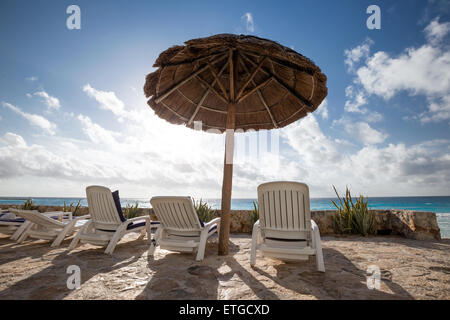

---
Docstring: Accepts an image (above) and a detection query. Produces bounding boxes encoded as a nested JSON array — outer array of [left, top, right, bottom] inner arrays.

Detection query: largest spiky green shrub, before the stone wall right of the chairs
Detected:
[[331, 186, 377, 236]]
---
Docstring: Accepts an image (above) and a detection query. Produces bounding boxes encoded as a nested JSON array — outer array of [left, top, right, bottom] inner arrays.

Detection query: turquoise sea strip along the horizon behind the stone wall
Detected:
[[0, 196, 450, 238]]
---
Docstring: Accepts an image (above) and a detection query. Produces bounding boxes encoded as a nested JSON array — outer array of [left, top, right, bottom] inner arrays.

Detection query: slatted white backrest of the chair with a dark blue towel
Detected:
[[86, 186, 122, 231]]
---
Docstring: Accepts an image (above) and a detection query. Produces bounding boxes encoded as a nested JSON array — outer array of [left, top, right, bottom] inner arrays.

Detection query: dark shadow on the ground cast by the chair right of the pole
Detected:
[[253, 248, 413, 300]]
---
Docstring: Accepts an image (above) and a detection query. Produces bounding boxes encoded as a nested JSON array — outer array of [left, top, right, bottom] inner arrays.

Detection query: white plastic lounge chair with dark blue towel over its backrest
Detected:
[[69, 186, 155, 254]]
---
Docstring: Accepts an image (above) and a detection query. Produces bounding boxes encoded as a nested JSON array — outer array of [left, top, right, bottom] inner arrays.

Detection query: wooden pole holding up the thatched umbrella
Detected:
[[219, 49, 237, 255]]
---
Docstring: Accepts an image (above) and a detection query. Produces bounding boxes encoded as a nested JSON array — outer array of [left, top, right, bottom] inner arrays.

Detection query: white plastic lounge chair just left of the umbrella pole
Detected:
[[149, 197, 220, 261]]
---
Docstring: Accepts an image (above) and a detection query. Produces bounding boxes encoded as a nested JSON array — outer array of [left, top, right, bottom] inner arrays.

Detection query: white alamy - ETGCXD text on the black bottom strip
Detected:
[[179, 304, 270, 318]]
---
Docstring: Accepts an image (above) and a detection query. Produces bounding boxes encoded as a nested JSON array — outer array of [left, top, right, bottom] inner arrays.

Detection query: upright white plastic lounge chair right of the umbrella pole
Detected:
[[250, 181, 325, 272]]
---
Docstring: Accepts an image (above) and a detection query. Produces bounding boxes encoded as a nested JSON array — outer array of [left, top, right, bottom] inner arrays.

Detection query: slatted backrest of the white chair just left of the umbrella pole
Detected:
[[150, 197, 202, 231]]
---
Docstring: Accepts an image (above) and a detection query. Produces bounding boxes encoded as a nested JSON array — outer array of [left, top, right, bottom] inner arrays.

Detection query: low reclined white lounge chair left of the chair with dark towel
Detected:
[[9, 208, 89, 247]]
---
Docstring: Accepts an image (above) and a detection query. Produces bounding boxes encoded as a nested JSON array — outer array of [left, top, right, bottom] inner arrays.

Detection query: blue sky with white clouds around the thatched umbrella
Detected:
[[0, 0, 450, 198]]
